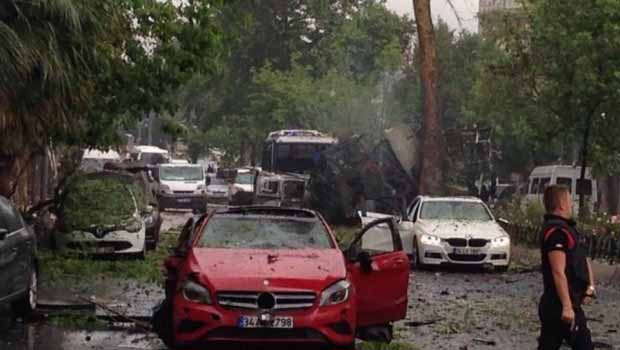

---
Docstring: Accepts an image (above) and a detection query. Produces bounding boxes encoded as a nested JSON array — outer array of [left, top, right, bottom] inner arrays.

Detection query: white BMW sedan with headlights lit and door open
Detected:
[[360, 196, 510, 271]]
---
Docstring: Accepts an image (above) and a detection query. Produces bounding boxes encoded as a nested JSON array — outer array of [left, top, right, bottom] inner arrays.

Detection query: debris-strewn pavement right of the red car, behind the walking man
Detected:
[[396, 269, 620, 350]]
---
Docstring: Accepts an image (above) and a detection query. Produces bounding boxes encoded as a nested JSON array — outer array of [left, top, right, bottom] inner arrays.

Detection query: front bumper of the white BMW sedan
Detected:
[[418, 241, 510, 266]]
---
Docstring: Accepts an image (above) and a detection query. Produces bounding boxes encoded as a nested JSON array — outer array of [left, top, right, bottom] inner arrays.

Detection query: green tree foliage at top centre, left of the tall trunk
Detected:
[[179, 0, 413, 163]]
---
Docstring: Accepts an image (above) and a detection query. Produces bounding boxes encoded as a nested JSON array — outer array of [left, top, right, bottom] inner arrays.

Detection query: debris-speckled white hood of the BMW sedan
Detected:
[[416, 220, 507, 239]]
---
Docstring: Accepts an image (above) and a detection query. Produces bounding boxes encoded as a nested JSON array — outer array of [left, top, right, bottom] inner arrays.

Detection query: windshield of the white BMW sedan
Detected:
[[420, 201, 492, 221]]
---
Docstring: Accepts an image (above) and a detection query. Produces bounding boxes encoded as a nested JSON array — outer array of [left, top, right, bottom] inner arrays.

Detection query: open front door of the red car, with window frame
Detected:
[[346, 217, 409, 333]]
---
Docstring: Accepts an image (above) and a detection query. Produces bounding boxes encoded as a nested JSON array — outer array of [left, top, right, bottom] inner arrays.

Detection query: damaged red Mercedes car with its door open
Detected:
[[153, 207, 409, 349]]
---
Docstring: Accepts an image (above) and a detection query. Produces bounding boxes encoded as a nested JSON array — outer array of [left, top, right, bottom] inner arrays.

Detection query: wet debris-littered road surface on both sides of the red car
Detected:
[[0, 212, 620, 350]]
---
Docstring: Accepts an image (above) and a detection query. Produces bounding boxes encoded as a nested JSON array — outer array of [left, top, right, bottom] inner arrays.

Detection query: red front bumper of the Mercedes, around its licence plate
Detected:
[[173, 295, 355, 347]]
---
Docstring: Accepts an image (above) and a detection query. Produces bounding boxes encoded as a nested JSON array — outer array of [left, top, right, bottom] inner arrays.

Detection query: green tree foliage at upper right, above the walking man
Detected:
[[471, 0, 620, 172]]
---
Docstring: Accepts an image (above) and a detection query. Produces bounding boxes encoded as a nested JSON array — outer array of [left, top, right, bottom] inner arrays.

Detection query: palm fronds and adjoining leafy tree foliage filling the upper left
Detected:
[[0, 0, 221, 155]]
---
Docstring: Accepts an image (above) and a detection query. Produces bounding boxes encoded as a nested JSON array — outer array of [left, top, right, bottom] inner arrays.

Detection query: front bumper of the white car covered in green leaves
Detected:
[[57, 226, 146, 254]]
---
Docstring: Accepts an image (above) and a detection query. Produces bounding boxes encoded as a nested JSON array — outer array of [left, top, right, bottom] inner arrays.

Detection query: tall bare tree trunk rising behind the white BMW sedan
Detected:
[[413, 0, 445, 195]]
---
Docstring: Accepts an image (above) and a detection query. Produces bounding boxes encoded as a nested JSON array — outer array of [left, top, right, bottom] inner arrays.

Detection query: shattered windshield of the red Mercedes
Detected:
[[198, 215, 333, 249]]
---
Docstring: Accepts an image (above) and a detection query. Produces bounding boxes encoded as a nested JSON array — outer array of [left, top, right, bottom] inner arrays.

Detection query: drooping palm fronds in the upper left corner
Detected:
[[0, 0, 99, 154]]
